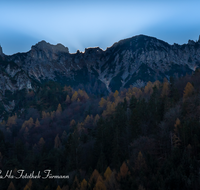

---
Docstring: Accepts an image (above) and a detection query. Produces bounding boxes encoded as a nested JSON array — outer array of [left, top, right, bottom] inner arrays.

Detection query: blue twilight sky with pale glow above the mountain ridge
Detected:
[[0, 0, 200, 55]]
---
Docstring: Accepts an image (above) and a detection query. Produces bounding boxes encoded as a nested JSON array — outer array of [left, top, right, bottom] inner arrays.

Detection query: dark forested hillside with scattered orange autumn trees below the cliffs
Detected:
[[0, 70, 200, 190]]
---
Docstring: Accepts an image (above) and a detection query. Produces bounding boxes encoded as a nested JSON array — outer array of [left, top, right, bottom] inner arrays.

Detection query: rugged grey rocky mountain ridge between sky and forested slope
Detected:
[[1, 35, 200, 94]]
